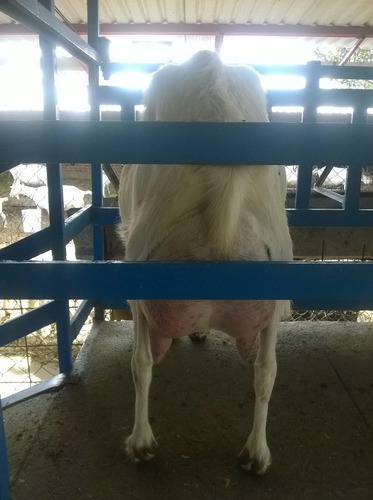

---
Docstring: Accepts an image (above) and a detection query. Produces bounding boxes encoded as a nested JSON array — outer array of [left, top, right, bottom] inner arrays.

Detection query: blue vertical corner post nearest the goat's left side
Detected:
[[87, 0, 105, 320]]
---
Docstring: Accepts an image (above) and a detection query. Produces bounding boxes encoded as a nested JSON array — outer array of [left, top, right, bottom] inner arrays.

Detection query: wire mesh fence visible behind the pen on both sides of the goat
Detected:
[[0, 165, 373, 397]]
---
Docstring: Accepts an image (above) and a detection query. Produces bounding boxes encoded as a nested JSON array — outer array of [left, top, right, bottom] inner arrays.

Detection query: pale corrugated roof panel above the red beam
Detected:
[[0, 0, 373, 26]]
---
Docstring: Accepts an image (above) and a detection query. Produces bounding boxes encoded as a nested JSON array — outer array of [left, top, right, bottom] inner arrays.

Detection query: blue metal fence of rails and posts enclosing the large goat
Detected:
[[0, 1, 373, 499]]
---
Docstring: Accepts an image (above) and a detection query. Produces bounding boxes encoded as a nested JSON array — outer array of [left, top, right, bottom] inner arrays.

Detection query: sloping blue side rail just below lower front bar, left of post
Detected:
[[0, 297, 55, 347]]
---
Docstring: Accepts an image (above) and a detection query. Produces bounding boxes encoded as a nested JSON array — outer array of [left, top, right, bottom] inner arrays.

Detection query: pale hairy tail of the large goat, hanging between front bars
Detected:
[[202, 166, 246, 259]]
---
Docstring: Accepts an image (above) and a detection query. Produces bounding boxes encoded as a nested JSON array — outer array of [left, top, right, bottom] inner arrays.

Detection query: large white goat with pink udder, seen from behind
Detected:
[[119, 51, 292, 474]]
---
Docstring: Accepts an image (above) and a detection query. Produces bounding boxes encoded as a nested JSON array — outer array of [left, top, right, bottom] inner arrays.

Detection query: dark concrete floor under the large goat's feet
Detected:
[[4, 322, 373, 500]]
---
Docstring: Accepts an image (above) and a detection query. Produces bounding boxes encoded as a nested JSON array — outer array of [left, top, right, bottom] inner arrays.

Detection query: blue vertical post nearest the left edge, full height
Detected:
[[40, 0, 72, 373]]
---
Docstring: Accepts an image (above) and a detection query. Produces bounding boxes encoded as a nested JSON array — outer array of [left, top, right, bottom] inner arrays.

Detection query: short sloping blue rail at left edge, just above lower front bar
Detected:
[[0, 227, 51, 260]]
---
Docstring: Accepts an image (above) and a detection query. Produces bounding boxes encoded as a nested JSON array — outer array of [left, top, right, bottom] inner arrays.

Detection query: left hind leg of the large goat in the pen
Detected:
[[126, 302, 156, 462]]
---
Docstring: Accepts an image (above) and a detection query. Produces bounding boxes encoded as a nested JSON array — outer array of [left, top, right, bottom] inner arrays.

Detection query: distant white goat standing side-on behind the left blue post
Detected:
[[9, 182, 92, 213]]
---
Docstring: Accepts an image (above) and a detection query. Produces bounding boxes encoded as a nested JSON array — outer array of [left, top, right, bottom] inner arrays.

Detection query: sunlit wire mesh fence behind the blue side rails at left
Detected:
[[0, 164, 96, 397]]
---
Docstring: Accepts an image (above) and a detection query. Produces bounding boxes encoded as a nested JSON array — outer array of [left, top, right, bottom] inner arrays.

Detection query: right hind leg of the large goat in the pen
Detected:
[[240, 313, 279, 474]]
